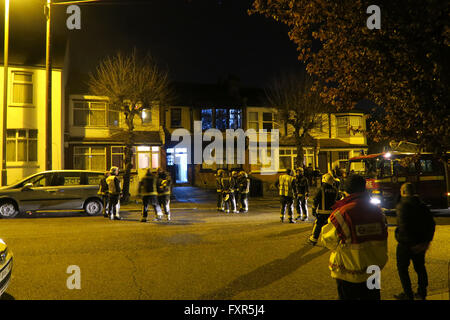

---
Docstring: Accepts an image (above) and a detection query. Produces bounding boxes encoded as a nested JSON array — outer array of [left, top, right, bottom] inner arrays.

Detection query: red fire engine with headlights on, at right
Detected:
[[347, 152, 449, 210]]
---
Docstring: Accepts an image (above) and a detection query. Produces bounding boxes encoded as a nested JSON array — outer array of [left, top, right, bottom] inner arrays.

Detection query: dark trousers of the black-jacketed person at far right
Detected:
[[397, 243, 428, 299]]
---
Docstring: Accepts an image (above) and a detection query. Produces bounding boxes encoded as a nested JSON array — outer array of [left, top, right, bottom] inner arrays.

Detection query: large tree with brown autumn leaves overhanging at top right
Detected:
[[249, 0, 450, 156]]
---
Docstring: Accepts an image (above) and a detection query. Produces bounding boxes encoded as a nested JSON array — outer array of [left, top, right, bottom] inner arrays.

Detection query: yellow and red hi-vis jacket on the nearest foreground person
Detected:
[[319, 192, 388, 283]]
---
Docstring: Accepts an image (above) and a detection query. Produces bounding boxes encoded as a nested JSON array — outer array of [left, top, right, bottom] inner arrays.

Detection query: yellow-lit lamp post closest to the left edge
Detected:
[[1, 0, 9, 186]]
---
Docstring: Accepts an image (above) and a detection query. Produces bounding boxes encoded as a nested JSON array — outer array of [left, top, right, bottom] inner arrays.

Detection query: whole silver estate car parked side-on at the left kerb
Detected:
[[0, 170, 104, 218]]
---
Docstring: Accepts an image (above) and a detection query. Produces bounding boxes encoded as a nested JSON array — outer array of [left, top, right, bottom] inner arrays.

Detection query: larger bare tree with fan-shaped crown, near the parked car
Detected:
[[89, 49, 172, 202]]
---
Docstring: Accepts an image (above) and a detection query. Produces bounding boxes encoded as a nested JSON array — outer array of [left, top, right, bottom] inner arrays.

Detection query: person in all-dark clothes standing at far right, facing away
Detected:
[[394, 182, 436, 300]]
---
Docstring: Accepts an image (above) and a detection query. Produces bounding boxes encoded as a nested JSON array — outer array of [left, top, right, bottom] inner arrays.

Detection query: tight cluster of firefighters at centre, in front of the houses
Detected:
[[216, 169, 250, 213]]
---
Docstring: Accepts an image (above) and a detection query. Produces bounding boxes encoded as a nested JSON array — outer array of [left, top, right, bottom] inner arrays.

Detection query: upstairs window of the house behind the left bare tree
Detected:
[[73, 100, 107, 127]]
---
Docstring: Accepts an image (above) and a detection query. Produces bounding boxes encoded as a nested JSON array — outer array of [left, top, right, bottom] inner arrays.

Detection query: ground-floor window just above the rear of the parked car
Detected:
[[73, 147, 106, 171]]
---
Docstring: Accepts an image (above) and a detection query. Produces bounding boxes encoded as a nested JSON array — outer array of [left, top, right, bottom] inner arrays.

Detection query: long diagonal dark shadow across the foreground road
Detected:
[[199, 245, 328, 300]]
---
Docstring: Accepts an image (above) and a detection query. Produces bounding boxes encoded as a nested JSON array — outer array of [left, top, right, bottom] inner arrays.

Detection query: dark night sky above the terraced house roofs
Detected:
[[2, 0, 302, 86]]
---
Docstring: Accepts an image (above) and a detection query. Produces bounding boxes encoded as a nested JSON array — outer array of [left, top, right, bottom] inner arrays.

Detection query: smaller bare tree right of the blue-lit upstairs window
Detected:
[[266, 73, 329, 168]]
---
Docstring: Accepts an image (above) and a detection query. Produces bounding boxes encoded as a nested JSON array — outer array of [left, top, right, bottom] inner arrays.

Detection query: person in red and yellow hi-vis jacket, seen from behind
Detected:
[[320, 175, 388, 300]]
